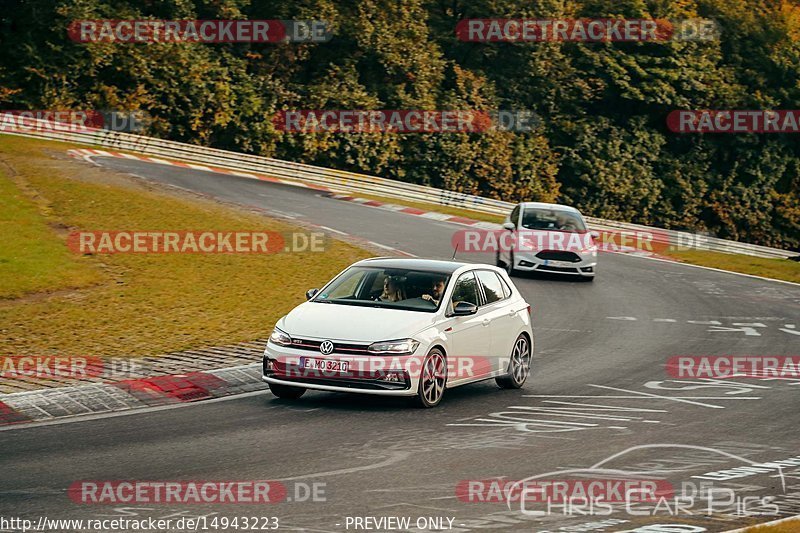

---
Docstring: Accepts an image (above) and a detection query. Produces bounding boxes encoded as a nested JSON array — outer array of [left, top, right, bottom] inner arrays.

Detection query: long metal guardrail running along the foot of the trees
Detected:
[[0, 117, 798, 258]]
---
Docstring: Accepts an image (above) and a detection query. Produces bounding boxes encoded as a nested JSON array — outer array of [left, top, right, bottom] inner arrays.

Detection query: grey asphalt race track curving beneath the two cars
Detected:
[[0, 158, 800, 533]]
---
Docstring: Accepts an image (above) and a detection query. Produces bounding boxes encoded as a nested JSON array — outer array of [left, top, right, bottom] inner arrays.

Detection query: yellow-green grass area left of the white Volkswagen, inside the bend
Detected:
[[0, 135, 370, 356]]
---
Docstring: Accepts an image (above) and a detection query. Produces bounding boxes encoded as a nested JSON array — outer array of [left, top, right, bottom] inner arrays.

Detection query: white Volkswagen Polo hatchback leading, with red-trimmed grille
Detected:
[[263, 258, 533, 407]]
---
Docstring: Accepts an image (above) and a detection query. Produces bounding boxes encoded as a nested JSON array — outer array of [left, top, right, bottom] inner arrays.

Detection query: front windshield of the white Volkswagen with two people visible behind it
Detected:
[[311, 266, 450, 313]]
